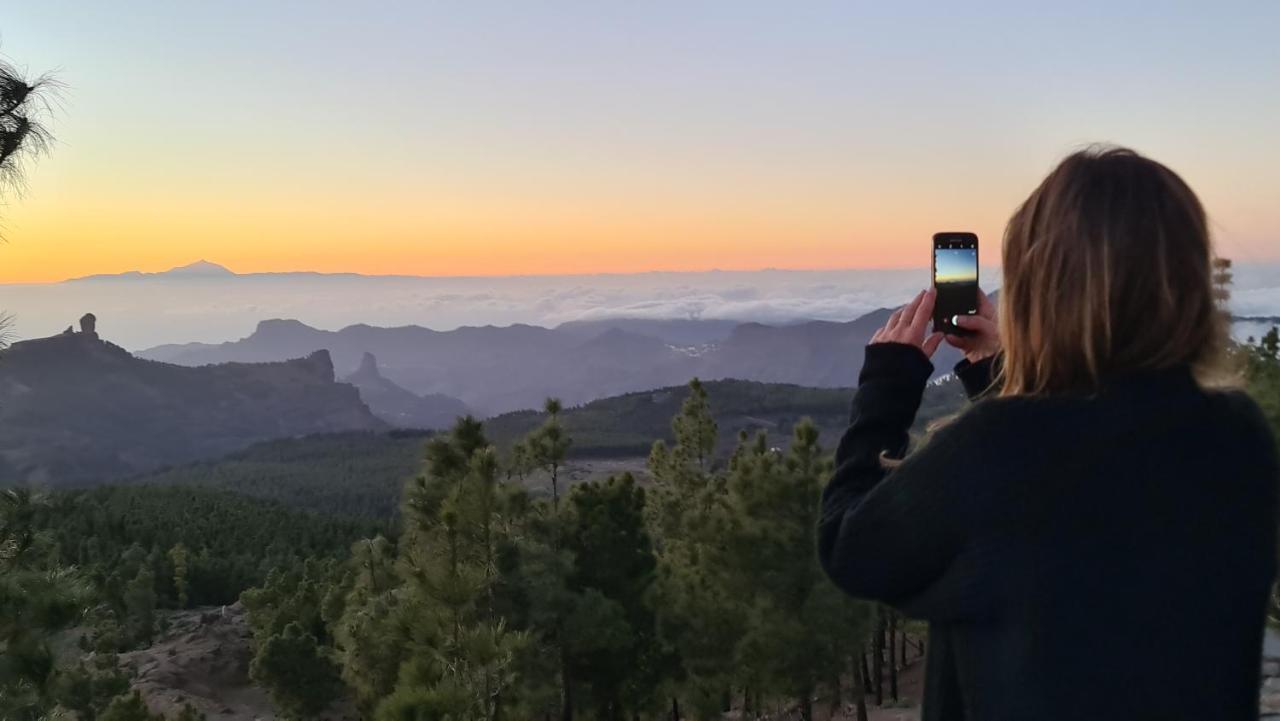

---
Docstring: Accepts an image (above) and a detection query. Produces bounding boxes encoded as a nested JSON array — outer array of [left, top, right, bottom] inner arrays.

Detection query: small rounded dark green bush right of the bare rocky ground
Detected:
[[250, 622, 342, 720]]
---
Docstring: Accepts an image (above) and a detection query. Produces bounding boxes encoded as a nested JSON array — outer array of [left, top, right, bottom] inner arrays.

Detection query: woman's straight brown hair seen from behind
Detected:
[[1000, 147, 1225, 396]]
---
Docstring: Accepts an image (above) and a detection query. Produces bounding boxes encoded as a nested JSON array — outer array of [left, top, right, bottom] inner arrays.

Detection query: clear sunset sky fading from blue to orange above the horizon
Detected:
[[0, 0, 1280, 283]]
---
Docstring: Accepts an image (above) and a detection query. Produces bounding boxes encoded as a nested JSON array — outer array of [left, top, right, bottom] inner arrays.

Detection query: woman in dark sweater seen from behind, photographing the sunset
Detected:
[[819, 149, 1280, 721]]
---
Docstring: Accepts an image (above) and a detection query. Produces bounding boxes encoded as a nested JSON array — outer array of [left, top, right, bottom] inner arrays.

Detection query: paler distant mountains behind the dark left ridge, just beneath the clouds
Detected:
[[140, 310, 959, 416]]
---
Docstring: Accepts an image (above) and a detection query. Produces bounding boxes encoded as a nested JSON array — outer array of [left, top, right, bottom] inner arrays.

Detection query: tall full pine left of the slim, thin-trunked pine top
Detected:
[[368, 419, 525, 721]]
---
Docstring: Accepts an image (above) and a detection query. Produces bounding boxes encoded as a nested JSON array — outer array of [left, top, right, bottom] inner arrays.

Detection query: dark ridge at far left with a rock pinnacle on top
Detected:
[[0, 316, 385, 487]]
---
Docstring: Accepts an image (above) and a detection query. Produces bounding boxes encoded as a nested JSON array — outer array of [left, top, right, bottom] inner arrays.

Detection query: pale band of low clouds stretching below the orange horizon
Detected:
[[0, 264, 1280, 350]]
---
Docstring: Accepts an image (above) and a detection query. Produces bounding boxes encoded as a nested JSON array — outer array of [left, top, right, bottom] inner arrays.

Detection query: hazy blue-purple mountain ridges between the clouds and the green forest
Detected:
[[0, 299, 955, 485]]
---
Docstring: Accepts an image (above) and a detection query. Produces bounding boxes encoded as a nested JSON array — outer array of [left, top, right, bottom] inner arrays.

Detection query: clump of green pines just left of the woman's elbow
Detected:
[[649, 383, 869, 717]]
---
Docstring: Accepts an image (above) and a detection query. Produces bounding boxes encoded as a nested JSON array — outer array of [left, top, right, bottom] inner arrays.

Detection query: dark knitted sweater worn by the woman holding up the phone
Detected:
[[819, 343, 1280, 721]]
